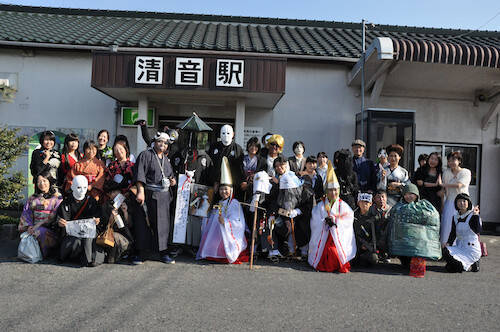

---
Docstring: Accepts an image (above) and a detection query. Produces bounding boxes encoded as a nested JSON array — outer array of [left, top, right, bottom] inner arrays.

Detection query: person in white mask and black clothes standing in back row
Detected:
[[208, 124, 243, 194]]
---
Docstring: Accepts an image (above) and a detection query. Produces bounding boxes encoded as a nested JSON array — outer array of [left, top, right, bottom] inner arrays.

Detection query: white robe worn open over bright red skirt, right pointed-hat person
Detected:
[[308, 198, 356, 268]]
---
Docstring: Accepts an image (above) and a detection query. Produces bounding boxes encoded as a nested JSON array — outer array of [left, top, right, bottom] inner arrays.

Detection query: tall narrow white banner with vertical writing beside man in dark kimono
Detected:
[[172, 174, 191, 243]]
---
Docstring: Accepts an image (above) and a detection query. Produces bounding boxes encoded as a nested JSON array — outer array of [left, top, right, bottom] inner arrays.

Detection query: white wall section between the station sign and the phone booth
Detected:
[[245, 61, 360, 157]]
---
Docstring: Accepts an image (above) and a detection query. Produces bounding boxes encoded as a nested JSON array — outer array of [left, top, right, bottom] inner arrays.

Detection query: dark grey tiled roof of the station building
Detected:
[[0, 5, 500, 60]]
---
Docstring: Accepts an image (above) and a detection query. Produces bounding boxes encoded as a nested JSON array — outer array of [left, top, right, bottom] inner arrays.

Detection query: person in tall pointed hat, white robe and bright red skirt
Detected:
[[308, 163, 357, 273]]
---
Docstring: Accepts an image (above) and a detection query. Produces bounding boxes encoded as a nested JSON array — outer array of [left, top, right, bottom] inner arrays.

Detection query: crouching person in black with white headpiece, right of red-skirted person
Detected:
[[353, 193, 378, 266]]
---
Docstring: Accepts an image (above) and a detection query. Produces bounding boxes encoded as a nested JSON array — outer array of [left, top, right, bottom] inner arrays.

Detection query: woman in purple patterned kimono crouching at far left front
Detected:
[[18, 170, 62, 257]]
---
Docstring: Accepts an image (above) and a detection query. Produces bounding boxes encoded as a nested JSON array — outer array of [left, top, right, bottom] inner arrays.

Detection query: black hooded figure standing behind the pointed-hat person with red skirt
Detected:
[[333, 149, 359, 210]]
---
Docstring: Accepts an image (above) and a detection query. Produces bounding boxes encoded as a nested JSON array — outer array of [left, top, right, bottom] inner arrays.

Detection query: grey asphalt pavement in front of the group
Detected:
[[0, 236, 500, 331]]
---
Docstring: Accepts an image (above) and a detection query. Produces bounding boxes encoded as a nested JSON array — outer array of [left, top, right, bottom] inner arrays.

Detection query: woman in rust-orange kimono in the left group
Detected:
[[65, 141, 106, 200]]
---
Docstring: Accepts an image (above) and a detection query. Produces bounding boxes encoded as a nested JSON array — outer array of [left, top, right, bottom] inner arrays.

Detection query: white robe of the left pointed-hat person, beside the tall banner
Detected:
[[196, 199, 247, 263]]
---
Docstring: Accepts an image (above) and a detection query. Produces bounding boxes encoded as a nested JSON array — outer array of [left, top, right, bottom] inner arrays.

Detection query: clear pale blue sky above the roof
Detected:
[[0, 0, 500, 31]]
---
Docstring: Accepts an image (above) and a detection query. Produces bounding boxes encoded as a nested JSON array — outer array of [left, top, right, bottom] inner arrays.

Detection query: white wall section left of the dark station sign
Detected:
[[0, 49, 115, 196]]
